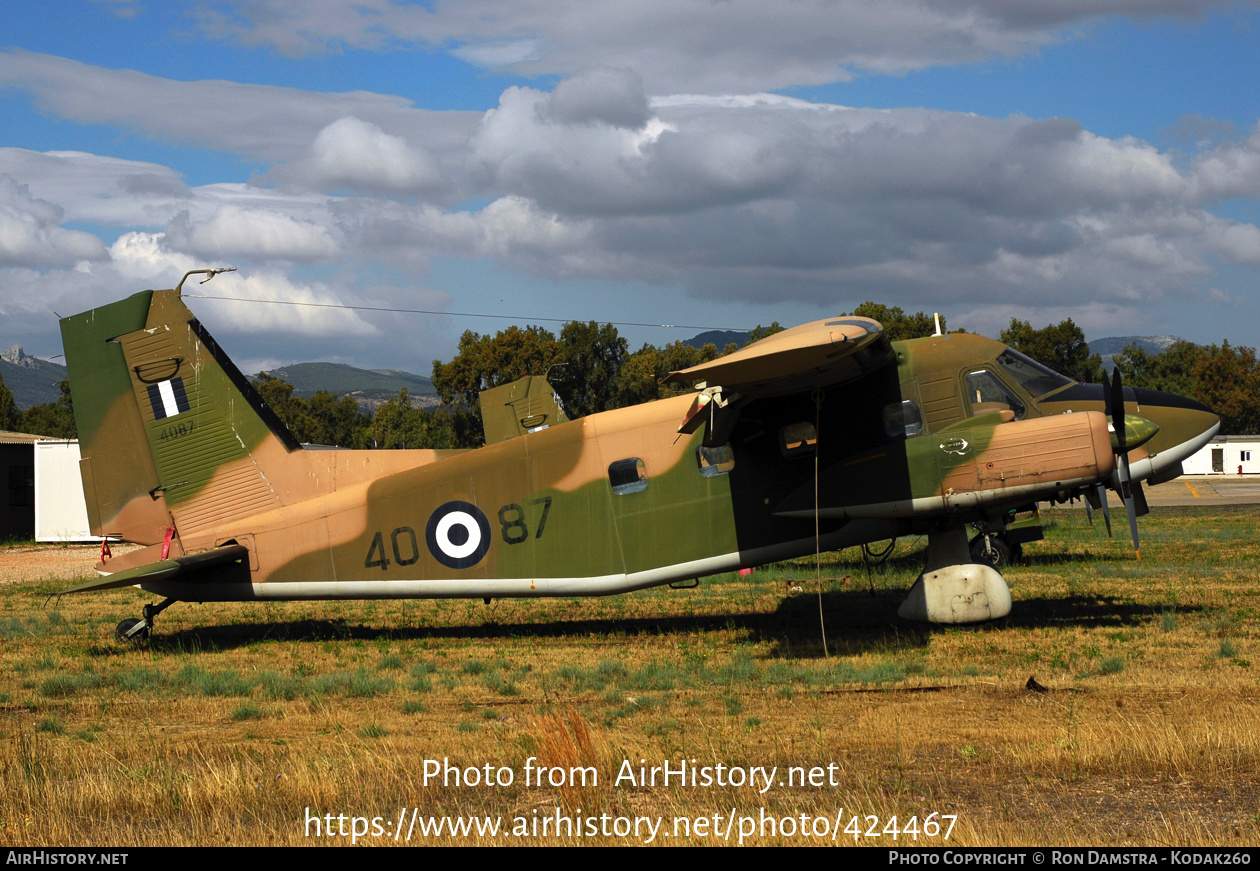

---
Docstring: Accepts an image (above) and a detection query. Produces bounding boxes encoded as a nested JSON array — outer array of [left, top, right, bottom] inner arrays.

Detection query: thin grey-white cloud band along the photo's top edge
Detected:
[[191, 0, 1229, 93]]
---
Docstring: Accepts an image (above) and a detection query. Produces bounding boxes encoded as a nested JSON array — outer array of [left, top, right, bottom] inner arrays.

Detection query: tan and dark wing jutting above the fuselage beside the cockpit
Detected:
[[665, 316, 896, 397]]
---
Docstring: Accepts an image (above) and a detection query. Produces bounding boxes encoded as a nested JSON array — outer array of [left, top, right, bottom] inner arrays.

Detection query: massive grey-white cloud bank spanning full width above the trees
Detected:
[[0, 50, 1260, 360]]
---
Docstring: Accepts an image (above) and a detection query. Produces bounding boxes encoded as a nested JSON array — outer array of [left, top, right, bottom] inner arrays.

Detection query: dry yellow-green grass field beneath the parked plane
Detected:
[[0, 507, 1260, 846]]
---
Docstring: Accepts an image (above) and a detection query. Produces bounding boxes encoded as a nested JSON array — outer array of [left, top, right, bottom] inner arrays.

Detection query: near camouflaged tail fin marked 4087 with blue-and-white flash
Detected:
[[62, 290, 301, 543]]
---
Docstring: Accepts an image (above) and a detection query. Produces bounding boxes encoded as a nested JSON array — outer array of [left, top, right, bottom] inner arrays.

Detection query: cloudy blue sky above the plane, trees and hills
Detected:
[[0, 0, 1260, 374]]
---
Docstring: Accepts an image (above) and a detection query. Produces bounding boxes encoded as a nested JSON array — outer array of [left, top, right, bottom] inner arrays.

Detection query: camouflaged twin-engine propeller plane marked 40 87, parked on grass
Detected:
[[62, 270, 1220, 639]]
